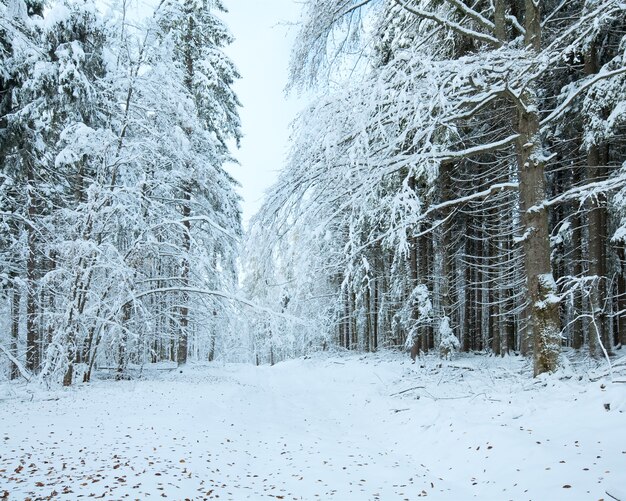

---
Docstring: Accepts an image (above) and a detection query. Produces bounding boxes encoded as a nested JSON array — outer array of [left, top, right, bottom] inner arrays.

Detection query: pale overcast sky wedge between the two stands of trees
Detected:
[[224, 0, 301, 226]]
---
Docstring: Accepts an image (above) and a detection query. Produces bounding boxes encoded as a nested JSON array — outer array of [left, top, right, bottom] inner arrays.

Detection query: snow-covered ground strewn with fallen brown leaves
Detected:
[[0, 353, 626, 501]]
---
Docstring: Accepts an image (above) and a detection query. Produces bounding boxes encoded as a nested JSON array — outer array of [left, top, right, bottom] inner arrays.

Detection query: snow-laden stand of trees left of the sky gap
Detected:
[[0, 0, 241, 385]]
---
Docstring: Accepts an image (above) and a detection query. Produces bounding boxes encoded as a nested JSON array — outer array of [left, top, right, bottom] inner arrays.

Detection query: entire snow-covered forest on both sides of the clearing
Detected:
[[0, 0, 626, 378]]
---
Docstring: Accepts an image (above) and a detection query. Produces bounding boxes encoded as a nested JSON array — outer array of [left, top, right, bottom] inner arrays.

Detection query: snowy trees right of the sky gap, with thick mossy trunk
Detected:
[[249, 0, 626, 374]]
